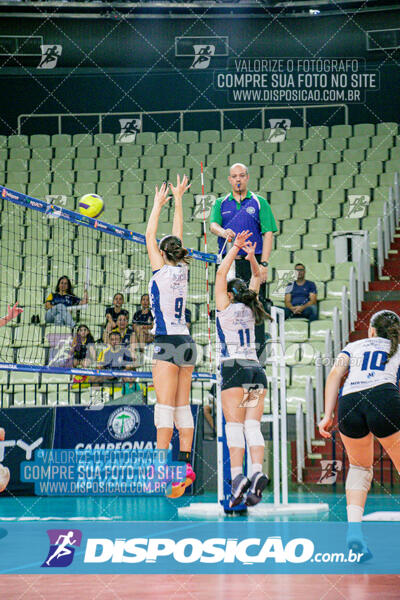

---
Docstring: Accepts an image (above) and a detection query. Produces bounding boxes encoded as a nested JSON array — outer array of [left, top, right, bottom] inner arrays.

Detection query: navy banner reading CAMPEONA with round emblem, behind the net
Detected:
[[51, 405, 199, 496]]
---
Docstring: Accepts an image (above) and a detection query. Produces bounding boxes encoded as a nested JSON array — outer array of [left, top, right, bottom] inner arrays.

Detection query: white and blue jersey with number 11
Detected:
[[217, 302, 258, 362]]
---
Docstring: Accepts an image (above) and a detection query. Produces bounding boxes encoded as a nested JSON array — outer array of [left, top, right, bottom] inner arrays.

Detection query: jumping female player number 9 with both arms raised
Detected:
[[146, 175, 196, 498]]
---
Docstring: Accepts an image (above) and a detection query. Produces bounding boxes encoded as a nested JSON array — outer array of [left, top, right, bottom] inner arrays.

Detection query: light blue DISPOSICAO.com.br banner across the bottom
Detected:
[[0, 521, 400, 575]]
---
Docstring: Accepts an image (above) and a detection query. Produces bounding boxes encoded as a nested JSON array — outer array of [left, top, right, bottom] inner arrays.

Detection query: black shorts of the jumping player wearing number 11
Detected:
[[221, 359, 267, 391]]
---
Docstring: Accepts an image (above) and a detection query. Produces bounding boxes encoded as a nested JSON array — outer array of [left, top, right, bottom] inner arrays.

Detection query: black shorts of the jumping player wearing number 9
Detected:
[[153, 335, 197, 367]]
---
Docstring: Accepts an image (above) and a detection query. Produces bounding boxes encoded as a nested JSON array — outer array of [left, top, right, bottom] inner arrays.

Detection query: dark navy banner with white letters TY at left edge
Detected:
[[0, 407, 54, 495]]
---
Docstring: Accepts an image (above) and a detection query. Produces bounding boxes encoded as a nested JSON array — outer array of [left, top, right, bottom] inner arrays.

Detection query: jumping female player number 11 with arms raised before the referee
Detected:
[[215, 231, 270, 507]]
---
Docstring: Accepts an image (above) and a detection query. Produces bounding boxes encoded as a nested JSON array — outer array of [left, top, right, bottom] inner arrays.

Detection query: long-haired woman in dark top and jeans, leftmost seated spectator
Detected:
[[45, 275, 89, 328]]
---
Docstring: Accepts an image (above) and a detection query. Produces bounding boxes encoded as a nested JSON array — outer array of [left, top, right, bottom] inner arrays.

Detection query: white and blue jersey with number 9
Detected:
[[149, 263, 189, 335]]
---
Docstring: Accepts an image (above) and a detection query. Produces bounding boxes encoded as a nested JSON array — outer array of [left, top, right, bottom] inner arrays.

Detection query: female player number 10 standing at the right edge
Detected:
[[319, 310, 400, 560]]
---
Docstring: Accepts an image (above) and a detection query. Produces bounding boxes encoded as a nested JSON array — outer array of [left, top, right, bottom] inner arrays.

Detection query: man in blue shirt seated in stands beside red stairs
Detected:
[[285, 263, 318, 321]]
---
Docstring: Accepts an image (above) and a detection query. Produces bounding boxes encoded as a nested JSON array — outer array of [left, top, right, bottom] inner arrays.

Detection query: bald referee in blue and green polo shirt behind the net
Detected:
[[210, 163, 277, 364]]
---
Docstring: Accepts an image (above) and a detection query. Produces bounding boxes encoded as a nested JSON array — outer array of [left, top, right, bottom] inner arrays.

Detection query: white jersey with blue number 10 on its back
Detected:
[[341, 337, 400, 396]]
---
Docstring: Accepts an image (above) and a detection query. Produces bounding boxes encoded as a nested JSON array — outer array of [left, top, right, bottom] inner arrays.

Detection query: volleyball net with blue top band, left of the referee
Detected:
[[0, 186, 217, 379]]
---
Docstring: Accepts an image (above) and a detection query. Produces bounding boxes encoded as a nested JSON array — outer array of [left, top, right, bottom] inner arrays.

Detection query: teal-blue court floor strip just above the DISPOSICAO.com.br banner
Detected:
[[0, 486, 400, 522]]
